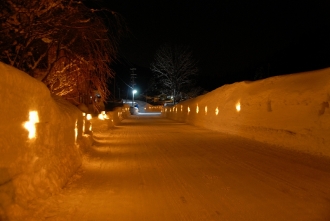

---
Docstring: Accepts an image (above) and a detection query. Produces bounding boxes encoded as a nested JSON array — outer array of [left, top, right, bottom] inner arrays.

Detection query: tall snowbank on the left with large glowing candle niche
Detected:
[[0, 62, 83, 220]]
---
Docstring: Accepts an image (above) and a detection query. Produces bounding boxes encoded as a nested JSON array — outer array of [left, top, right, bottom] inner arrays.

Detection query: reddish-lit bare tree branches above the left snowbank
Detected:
[[0, 0, 126, 110]]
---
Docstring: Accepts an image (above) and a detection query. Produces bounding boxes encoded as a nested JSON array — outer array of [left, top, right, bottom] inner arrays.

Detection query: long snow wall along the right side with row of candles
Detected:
[[162, 68, 330, 157]]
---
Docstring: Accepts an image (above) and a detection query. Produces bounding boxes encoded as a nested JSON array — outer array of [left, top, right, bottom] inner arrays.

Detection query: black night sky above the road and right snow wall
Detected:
[[103, 0, 330, 93]]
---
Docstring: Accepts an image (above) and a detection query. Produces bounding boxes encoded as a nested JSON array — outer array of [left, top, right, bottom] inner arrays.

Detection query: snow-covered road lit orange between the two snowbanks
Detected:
[[38, 115, 330, 221]]
